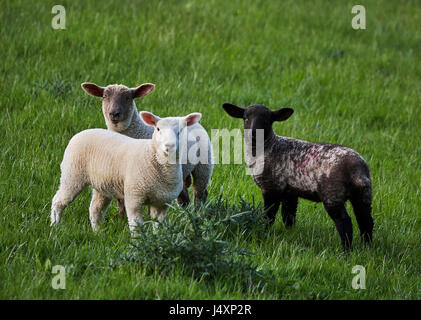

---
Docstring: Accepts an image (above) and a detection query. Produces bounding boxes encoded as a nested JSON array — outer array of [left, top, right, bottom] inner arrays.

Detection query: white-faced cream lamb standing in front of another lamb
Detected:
[[51, 112, 201, 232]]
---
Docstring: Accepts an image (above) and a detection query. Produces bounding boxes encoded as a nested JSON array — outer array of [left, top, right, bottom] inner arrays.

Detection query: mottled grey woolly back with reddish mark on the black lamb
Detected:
[[255, 136, 366, 198]]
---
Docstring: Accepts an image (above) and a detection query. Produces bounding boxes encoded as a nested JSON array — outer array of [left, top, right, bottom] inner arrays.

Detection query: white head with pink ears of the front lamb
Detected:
[[140, 111, 202, 157]]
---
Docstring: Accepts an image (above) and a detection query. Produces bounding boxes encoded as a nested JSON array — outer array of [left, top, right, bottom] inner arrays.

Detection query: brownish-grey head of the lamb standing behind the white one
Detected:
[[82, 82, 155, 132]]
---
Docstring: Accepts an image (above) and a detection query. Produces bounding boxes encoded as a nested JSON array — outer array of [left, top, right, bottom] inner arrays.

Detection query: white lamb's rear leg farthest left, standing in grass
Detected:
[[50, 179, 86, 225]]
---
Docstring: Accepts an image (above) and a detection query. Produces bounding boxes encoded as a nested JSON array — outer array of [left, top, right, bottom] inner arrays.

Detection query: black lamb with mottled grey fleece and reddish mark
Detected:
[[223, 103, 374, 249]]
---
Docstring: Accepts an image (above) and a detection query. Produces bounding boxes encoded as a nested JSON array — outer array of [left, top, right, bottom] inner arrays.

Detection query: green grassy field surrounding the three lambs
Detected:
[[0, 0, 421, 299]]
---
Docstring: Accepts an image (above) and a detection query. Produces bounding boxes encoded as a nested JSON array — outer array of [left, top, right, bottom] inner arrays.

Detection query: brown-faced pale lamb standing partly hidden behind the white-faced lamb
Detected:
[[82, 82, 213, 209]]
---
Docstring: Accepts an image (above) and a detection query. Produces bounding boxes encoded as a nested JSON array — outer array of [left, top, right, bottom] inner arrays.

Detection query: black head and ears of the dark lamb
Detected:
[[222, 103, 294, 139]]
